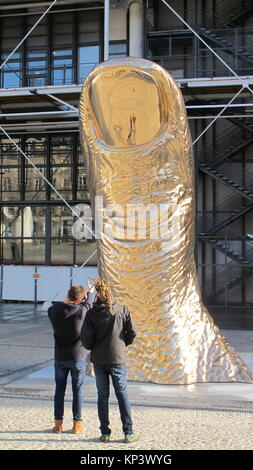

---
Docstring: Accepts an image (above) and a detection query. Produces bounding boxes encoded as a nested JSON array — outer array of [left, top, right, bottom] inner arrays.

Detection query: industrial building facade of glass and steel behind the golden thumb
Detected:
[[0, 0, 253, 328]]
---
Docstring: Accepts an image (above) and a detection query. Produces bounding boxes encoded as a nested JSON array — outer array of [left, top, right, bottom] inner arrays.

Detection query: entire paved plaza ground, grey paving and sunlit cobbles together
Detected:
[[0, 304, 253, 450]]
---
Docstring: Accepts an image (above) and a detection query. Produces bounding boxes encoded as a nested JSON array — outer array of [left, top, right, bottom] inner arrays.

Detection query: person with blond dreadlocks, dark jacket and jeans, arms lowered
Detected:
[[81, 280, 138, 442]]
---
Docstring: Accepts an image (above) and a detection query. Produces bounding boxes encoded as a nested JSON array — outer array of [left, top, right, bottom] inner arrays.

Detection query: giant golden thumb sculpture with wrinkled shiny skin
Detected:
[[80, 58, 253, 384]]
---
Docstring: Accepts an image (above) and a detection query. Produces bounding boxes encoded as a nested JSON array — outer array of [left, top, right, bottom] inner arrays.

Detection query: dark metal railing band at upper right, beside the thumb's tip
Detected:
[[147, 28, 253, 79]]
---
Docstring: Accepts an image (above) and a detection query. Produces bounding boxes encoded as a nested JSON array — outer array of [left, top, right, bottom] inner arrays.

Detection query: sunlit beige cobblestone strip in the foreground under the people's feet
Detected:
[[0, 398, 253, 450]]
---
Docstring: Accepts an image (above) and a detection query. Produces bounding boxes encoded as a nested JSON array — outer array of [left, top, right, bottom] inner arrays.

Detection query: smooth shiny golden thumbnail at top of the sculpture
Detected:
[[90, 69, 167, 147]]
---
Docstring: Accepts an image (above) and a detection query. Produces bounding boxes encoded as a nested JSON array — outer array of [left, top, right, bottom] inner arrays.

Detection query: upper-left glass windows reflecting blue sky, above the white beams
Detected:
[[0, 10, 103, 88]]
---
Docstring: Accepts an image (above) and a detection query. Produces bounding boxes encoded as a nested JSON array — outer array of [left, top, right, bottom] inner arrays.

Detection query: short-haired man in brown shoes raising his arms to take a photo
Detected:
[[48, 285, 94, 434]]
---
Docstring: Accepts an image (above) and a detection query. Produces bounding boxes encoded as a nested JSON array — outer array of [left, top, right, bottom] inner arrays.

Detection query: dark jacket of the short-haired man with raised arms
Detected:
[[48, 292, 92, 361]]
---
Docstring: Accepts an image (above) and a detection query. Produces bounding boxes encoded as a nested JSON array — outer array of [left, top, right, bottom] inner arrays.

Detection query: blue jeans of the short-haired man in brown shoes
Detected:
[[54, 360, 85, 421]]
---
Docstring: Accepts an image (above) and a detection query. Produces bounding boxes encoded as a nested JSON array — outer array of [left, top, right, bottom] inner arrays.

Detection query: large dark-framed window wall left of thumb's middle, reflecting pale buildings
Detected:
[[0, 134, 96, 265]]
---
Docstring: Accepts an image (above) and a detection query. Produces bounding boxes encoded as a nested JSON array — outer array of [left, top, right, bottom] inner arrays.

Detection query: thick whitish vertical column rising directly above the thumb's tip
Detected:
[[129, 0, 144, 57]]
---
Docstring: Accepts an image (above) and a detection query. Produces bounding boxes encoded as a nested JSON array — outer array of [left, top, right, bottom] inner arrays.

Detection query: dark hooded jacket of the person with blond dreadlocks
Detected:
[[81, 299, 136, 366]]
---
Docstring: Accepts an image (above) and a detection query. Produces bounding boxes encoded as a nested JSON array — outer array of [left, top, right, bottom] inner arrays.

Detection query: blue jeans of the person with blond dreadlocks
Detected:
[[94, 365, 133, 435]]
